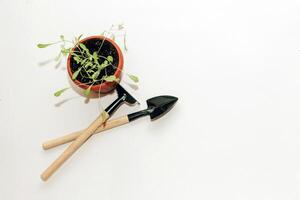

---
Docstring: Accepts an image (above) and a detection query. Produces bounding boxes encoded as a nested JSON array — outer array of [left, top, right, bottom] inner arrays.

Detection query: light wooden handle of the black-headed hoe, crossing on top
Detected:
[[41, 111, 109, 181]]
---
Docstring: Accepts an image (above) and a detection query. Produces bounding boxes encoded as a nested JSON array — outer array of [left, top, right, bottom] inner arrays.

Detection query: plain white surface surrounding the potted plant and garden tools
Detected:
[[0, 0, 300, 200]]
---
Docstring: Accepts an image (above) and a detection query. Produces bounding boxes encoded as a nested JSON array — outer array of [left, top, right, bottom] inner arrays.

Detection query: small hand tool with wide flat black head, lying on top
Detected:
[[41, 84, 137, 181]]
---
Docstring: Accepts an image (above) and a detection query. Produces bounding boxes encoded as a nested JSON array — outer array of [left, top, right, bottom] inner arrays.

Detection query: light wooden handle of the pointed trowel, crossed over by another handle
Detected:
[[43, 115, 129, 150]]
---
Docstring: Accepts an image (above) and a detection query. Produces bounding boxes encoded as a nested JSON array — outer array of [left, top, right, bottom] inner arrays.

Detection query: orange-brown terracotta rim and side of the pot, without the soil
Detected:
[[67, 36, 124, 93]]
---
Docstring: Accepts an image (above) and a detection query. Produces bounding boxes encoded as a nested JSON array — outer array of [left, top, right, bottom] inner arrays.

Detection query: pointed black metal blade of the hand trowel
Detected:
[[147, 95, 178, 120]]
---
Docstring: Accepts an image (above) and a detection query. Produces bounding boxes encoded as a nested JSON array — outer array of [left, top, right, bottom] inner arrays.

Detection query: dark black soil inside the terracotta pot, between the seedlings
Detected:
[[70, 39, 119, 85]]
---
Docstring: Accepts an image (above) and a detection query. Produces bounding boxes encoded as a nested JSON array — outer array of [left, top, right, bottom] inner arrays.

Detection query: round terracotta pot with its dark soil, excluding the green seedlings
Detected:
[[67, 36, 124, 93]]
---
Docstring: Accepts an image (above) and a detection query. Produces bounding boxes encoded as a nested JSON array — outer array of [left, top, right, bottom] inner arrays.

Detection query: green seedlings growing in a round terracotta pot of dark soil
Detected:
[[37, 24, 138, 96]]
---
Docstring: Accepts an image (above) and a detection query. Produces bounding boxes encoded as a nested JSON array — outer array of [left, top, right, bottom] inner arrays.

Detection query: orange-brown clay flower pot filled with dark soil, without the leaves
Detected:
[[67, 36, 124, 93]]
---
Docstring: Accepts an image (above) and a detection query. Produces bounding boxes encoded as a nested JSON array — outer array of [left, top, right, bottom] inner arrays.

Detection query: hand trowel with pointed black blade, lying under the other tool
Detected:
[[43, 95, 178, 150]]
